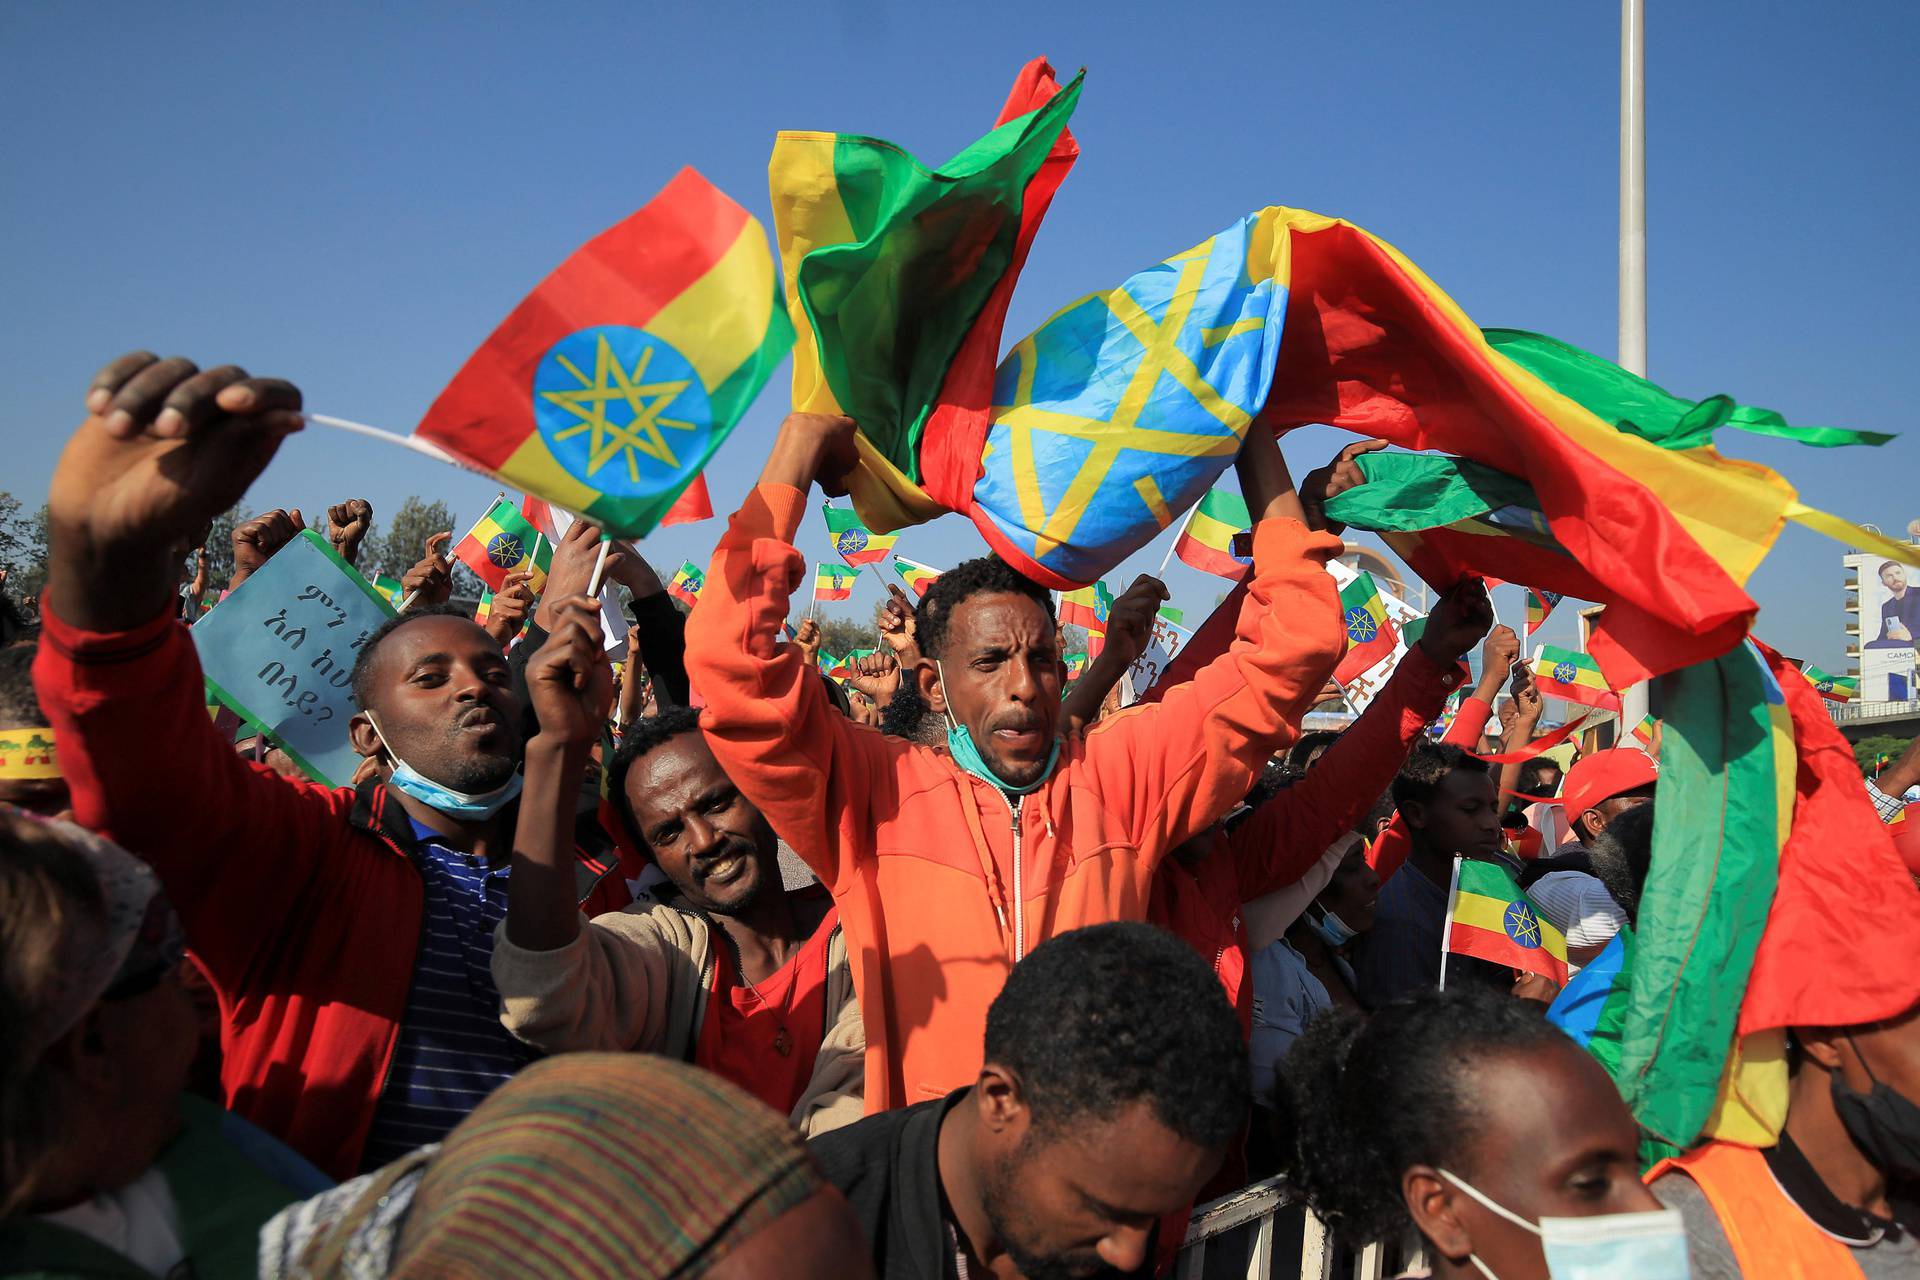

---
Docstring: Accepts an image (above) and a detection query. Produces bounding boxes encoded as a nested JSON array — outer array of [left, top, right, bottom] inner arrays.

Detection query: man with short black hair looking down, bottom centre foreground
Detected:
[[808, 923, 1248, 1280]]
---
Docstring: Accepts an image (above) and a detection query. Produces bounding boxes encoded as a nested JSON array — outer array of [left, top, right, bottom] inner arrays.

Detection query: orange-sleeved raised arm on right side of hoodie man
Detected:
[[1087, 426, 1346, 850]]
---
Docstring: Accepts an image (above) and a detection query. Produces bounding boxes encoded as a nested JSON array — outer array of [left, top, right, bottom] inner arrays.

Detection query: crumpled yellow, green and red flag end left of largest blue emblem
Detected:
[[768, 58, 1081, 532]]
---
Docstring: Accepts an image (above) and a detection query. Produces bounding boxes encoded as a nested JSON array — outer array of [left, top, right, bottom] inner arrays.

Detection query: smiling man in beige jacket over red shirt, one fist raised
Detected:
[[493, 601, 866, 1136]]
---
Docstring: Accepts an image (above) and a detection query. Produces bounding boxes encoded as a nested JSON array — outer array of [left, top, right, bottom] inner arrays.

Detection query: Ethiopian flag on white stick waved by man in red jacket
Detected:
[[417, 169, 793, 537]]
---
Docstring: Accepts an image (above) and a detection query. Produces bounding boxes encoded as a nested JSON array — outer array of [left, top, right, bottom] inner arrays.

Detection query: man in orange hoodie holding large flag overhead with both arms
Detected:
[[687, 415, 1346, 1111]]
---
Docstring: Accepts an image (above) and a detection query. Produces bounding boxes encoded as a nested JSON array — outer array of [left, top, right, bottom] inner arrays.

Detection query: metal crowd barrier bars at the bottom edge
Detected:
[[1173, 1178, 1423, 1280]]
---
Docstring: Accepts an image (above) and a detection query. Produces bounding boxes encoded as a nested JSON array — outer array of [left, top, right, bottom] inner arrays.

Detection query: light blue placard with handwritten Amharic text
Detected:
[[194, 530, 394, 787]]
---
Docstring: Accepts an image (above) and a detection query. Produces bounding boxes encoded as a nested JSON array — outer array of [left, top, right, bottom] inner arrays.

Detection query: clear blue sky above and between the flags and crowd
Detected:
[[0, 0, 1920, 670]]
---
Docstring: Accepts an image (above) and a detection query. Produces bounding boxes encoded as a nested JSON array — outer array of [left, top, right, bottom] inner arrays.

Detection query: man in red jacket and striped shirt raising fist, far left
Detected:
[[35, 353, 624, 1176]]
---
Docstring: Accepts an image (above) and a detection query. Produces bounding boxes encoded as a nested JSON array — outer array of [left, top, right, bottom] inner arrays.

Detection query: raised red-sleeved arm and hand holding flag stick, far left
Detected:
[[35, 353, 351, 979]]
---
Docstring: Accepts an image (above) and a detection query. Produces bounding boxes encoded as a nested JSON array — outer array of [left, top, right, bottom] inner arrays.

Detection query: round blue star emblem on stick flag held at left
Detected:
[[534, 324, 714, 497]]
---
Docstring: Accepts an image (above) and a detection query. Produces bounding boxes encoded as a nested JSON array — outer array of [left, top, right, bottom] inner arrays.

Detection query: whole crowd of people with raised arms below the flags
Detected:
[[0, 353, 1920, 1280]]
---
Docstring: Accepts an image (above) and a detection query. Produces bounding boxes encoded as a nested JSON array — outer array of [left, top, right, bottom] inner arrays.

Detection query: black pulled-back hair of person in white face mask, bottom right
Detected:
[[1277, 986, 1580, 1245]]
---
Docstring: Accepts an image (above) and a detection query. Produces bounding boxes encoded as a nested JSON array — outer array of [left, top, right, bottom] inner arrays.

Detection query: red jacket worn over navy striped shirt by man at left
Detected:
[[33, 603, 626, 1178]]
